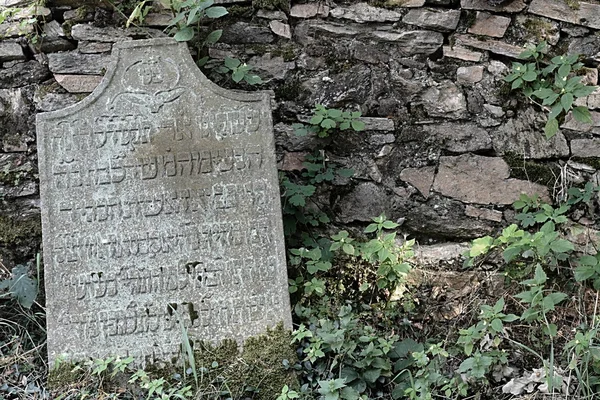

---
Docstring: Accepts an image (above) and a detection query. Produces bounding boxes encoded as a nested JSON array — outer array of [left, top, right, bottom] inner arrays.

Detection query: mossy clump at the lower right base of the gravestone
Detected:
[[195, 324, 298, 400]]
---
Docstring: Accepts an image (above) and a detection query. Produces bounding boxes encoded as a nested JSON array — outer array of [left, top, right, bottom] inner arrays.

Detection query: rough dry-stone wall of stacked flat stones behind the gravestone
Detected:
[[0, 0, 600, 265]]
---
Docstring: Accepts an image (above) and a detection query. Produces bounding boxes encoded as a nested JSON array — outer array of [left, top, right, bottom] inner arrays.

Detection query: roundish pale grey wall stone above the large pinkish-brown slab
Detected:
[[421, 81, 467, 119]]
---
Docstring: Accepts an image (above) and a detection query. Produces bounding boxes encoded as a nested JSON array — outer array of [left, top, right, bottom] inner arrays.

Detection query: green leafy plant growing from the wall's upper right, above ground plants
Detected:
[[504, 42, 596, 138]]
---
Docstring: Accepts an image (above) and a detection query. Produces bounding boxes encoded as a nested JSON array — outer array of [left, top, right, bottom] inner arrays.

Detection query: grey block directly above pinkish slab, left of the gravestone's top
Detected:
[[48, 52, 110, 75]]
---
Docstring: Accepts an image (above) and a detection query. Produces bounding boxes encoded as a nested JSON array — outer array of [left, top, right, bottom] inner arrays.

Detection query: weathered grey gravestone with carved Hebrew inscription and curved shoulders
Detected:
[[37, 39, 291, 364]]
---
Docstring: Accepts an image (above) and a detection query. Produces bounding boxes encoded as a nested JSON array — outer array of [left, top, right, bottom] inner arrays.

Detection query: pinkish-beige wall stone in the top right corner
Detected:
[[529, 0, 600, 29]]
